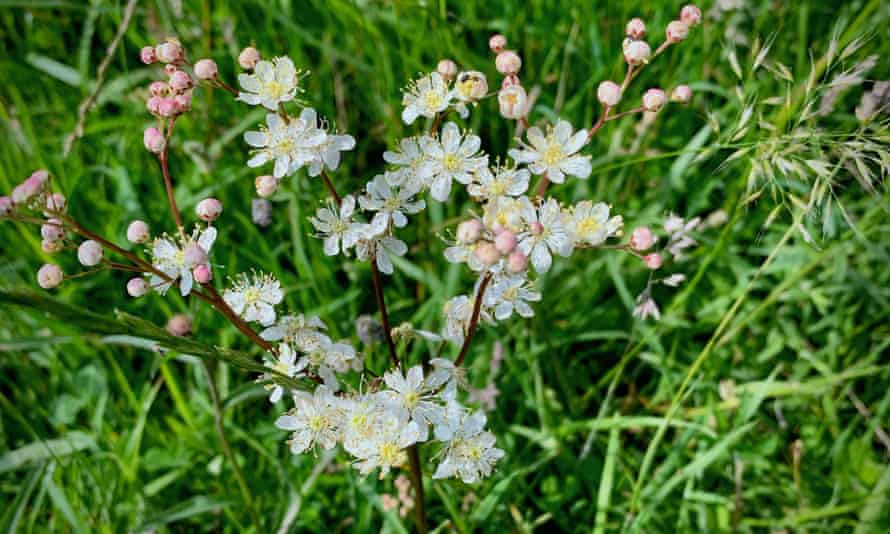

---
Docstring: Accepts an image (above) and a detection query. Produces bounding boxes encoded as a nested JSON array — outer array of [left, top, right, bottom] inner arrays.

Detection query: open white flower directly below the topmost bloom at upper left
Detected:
[[244, 113, 328, 178]]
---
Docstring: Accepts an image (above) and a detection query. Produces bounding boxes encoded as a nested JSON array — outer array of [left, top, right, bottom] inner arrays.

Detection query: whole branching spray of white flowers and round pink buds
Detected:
[[0, 6, 708, 509]]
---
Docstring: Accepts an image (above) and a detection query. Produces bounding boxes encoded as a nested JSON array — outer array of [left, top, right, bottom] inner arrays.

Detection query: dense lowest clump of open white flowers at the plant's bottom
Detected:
[[275, 359, 504, 484]]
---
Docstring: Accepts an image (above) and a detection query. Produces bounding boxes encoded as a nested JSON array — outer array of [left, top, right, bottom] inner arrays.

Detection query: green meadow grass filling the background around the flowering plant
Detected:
[[0, 0, 890, 534]]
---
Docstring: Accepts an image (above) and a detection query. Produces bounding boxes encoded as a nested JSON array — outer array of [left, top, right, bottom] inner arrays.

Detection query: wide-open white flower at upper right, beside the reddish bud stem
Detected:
[[509, 120, 591, 184]]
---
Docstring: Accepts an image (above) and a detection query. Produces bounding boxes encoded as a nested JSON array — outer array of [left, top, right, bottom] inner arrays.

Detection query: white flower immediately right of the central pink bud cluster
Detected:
[[519, 198, 572, 273]]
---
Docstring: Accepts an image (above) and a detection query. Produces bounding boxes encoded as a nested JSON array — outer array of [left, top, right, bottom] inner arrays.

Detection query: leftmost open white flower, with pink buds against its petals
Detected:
[[150, 226, 216, 296]]
